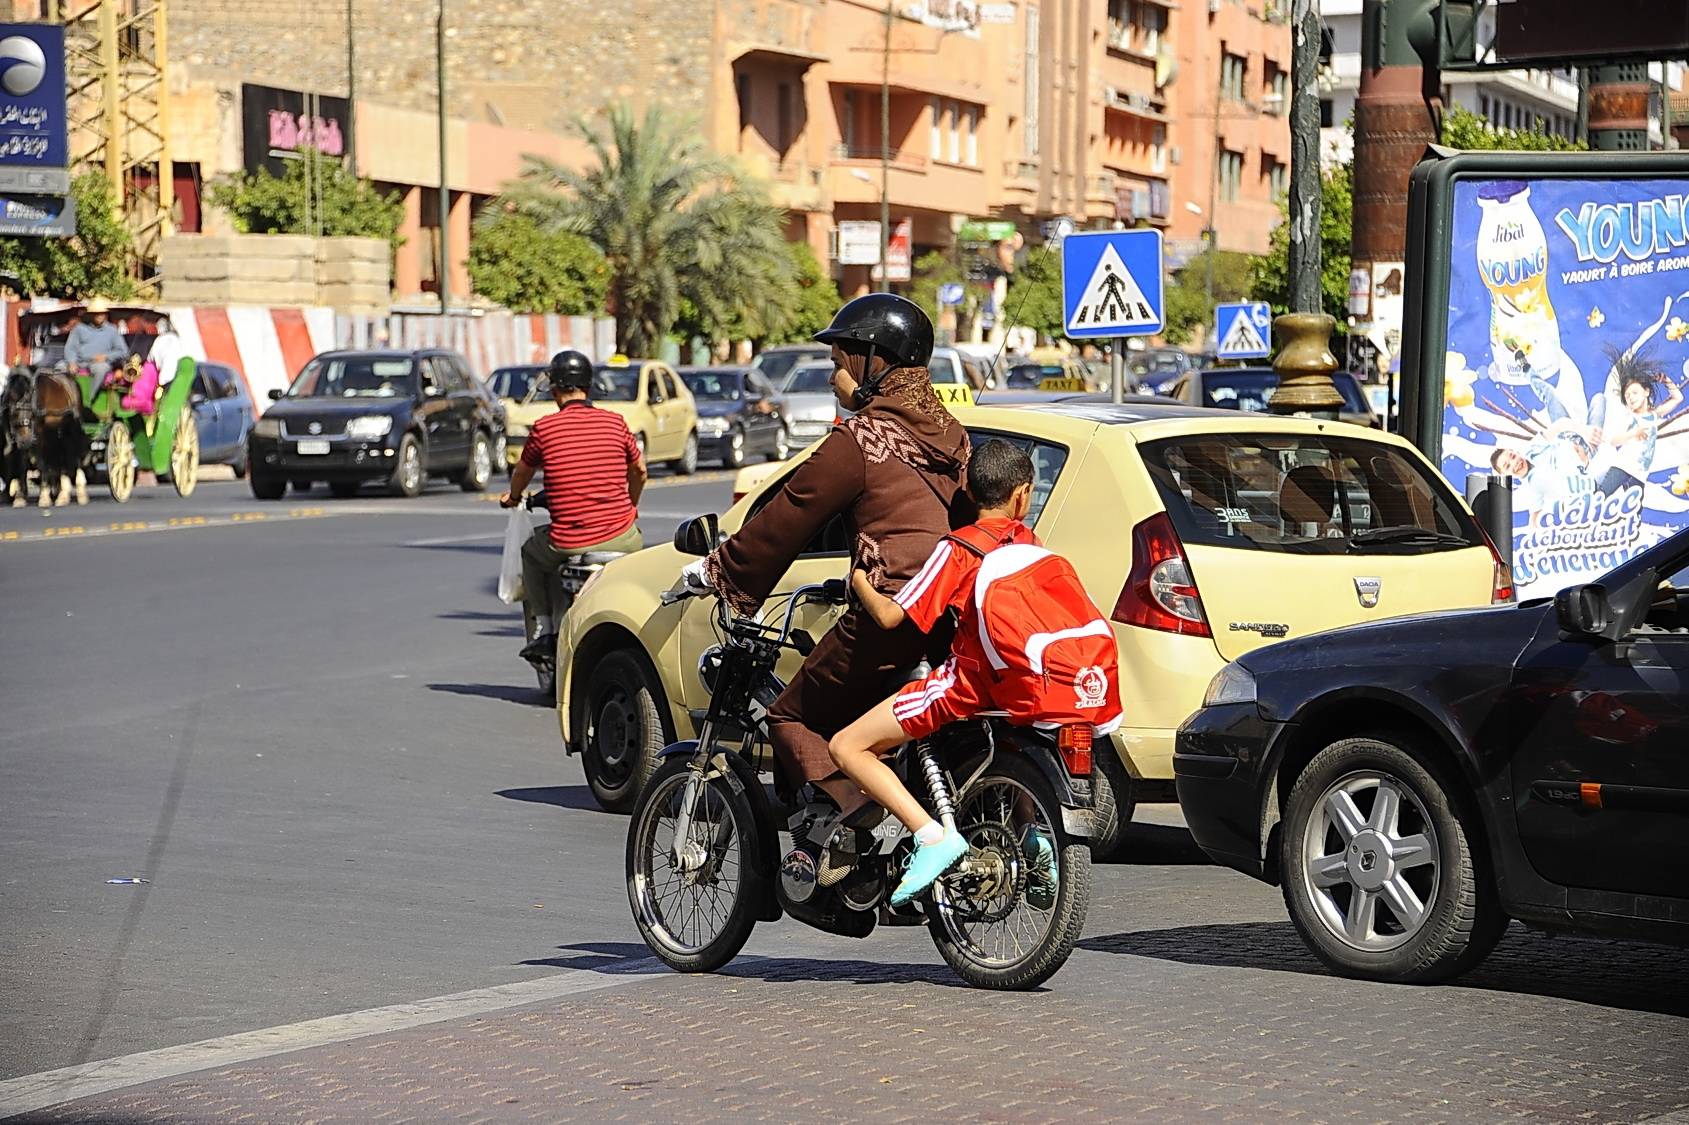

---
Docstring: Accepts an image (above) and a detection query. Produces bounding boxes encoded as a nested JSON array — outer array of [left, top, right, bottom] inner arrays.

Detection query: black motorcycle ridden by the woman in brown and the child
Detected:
[[627, 517, 1091, 988]]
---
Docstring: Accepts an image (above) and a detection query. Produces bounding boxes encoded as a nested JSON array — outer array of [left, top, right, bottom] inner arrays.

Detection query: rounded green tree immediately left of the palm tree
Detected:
[[470, 206, 610, 316]]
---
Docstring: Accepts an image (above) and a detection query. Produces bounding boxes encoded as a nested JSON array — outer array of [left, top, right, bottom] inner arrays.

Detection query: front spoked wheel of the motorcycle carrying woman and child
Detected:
[[627, 758, 765, 973]]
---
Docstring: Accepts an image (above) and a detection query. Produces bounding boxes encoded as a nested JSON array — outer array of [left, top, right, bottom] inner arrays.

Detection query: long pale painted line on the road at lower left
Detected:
[[0, 958, 659, 1118]]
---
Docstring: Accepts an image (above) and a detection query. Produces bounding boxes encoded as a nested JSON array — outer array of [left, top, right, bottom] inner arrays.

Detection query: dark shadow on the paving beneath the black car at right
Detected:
[[1079, 922, 1689, 1015]]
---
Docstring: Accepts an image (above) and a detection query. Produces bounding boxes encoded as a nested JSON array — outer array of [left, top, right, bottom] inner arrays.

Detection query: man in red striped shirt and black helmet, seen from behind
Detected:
[[498, 348, 645, 660]]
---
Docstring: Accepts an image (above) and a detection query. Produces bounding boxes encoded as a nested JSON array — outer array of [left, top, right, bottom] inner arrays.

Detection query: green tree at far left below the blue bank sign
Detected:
[[0, 172, 135, 301]]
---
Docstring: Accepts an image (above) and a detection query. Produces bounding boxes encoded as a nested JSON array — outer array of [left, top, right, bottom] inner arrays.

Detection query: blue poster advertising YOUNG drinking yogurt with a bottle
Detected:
[[1442, 179, 1689, 598]]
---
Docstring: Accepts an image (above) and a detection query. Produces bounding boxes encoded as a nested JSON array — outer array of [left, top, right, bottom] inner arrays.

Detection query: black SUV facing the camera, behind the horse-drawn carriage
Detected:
[[247, 350, 502, 500]]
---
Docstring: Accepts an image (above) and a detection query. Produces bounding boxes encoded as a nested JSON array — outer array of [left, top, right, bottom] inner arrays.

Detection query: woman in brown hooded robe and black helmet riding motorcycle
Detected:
[[684, 292, 973, 814]]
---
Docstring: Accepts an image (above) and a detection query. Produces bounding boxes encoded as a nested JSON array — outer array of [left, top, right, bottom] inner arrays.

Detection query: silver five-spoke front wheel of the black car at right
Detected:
[[1279, 738, 1507, 983]]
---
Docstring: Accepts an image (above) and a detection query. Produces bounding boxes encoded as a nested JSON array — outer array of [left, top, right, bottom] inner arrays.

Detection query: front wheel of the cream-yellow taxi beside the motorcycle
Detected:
[[581, 649, 669, 813]]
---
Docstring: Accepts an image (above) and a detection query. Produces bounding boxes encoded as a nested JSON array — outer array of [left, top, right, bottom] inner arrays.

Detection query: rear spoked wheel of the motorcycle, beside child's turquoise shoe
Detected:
[[927, 753, 1091, 988]]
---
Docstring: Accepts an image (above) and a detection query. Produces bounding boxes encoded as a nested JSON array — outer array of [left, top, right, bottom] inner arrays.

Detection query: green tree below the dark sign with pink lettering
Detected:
[[209, 149, 404, 248]]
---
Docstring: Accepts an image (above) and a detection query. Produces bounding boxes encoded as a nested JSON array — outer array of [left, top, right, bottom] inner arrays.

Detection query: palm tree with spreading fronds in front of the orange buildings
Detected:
[[505, 105, 796, 356]]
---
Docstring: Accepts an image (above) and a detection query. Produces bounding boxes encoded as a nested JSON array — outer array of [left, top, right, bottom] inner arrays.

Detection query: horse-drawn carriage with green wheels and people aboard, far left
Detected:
[[3, 302, 199, 507]]
